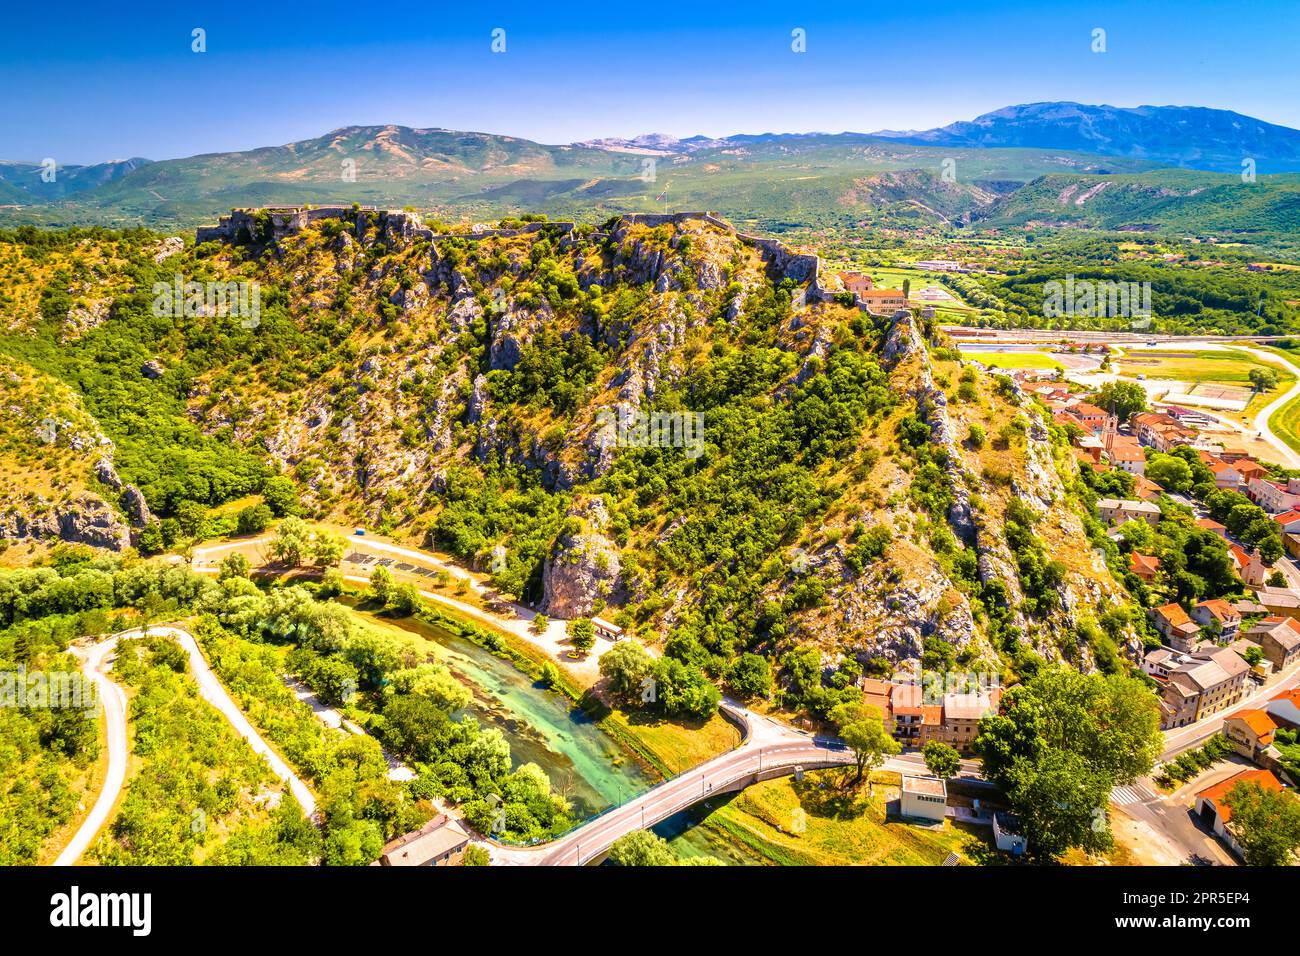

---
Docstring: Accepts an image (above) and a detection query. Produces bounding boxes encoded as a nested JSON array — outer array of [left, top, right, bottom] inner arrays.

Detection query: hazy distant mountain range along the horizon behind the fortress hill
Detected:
[[0, 103, 1300, 234]]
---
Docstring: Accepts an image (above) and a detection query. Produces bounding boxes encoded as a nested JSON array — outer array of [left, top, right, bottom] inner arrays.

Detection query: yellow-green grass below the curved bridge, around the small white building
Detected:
[[705, 770, 988, 866]]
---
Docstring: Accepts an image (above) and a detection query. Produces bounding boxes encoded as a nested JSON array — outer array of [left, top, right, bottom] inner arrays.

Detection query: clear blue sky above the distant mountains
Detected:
[[0, 0, 1300, 164]]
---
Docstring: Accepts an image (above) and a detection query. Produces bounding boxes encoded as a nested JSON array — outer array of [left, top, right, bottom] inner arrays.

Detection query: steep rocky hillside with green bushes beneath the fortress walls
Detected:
[[0, 211, 1139, 715]]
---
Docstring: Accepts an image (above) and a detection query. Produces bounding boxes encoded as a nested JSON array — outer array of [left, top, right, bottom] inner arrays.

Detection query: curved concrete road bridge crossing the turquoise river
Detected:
[[485, 704, 852, 866]]
